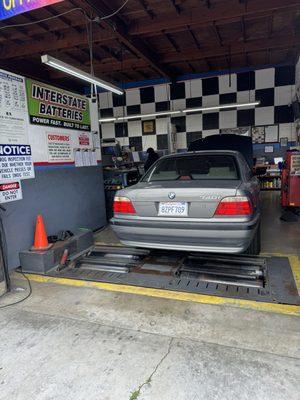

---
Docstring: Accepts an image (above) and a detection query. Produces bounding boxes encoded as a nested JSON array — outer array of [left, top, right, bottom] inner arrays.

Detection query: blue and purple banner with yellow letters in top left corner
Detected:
[[0, 0, 62, 21]]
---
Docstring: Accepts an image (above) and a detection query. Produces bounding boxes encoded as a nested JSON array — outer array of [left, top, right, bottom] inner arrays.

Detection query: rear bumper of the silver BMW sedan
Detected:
[[111, 215, 259, 254]]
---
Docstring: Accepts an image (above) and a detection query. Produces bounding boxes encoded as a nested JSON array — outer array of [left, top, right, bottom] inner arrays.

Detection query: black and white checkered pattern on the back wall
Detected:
[[99, 66, 295, 150]]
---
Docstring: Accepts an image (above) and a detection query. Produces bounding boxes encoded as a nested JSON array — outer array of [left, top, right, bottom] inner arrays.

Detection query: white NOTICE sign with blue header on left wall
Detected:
[[0, 144, 34, 182]]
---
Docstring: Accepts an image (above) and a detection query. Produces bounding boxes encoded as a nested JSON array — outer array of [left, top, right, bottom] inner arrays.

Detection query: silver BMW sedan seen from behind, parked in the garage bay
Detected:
[[111, 150, 260, 254]]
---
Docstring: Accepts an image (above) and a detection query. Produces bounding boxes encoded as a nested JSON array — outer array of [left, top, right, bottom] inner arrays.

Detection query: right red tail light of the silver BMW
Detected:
[[215, 196, 253, 216]]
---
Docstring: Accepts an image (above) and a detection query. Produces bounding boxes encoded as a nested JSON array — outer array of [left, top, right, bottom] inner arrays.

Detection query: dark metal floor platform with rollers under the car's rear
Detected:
[[47, 245, 300, 305]]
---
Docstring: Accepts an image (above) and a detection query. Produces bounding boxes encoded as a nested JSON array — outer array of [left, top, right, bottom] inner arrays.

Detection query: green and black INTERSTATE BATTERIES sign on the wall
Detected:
[[26, 79, 91, 131]]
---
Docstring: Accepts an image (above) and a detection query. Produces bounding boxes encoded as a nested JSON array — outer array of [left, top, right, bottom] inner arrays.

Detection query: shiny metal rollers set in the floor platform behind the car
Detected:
[[76, 246, 266, 288]]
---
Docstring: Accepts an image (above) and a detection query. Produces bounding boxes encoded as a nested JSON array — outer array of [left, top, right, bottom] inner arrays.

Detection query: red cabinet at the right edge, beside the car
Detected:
[[281, 150, 300, 208]]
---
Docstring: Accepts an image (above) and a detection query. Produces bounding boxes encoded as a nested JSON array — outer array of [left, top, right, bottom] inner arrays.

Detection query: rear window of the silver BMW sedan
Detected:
[[142, 154, 239, 182]]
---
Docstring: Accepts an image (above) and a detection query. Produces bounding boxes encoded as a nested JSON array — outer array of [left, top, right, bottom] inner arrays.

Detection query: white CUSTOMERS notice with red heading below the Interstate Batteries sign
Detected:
[[47, 133, 73, 162]]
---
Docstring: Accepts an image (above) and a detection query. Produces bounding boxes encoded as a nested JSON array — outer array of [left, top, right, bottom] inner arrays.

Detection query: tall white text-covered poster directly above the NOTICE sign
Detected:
[[0, 70, 28, 144]]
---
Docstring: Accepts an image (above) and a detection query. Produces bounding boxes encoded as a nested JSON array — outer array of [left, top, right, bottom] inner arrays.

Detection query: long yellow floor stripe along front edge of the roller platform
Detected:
[[26, 273, 300, 315]]
